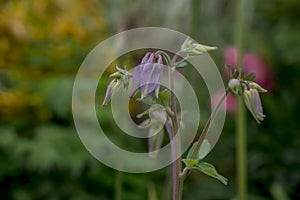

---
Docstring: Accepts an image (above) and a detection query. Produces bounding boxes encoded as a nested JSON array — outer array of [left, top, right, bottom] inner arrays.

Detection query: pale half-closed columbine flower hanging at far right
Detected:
[[243, 88, 265, 123]]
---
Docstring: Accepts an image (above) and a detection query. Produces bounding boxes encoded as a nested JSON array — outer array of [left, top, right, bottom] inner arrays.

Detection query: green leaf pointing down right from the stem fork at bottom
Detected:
[[193, 162, 228, 185]]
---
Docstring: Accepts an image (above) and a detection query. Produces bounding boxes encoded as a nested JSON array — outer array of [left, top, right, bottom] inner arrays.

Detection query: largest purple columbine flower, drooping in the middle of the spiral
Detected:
[[130, 52, 163, 98]]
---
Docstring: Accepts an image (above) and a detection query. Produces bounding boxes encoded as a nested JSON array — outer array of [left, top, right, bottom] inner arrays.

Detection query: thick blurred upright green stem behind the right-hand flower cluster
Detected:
[[235, 0, 247, 200]]
